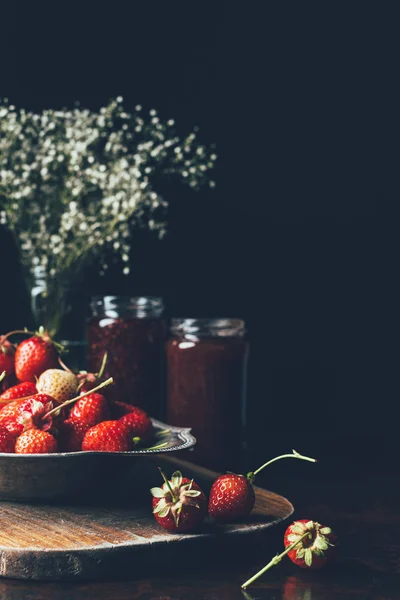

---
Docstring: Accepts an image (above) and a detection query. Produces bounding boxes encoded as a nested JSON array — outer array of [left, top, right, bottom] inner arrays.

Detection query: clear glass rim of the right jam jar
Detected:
[[171, 318, 246, 337]]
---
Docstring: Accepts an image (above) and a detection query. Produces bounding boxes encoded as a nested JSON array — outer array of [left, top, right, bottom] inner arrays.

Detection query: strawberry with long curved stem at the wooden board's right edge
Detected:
[[208, 450, 317, 522]]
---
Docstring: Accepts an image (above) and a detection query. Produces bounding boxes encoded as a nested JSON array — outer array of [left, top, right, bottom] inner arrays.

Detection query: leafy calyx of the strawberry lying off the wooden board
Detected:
[[287, 521, 334, 567]]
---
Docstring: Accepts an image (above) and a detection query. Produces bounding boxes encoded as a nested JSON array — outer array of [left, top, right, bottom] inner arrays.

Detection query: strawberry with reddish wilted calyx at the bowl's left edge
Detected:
[[0, 394, 54, 437]]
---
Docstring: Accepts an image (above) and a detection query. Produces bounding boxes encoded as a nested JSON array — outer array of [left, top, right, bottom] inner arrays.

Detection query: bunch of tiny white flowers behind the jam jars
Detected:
[[0, 97, 216, 336]]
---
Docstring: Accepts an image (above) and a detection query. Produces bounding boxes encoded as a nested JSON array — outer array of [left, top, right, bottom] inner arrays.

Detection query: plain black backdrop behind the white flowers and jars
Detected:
[[0, 1, 399, 466]]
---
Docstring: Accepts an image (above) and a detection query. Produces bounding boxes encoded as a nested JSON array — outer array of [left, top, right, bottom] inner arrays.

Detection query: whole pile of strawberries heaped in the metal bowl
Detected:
[[0, 329, 154, 454]]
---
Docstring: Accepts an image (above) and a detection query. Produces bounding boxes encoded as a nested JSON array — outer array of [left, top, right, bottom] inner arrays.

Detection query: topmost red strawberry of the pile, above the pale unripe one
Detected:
[[15, 332, 58, 382]]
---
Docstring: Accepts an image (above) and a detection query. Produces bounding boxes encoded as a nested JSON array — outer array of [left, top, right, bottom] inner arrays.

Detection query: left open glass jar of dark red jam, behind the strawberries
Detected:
[[86, 296, 166, 417]]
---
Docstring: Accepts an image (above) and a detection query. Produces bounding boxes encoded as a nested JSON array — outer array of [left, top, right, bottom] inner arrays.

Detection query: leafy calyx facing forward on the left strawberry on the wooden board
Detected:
[[150, 467, 201, 527]]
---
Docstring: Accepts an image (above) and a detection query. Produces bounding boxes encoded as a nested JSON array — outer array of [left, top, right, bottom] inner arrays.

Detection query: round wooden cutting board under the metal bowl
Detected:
[[0, 456, 293, 581]]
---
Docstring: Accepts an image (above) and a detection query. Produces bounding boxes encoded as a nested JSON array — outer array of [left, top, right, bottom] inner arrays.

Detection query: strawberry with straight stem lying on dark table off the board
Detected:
[[242, 519, 337, 589]]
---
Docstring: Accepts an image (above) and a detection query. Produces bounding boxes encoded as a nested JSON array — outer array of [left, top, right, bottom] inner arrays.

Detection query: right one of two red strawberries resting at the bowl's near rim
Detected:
[[82, 421, 133, 452]]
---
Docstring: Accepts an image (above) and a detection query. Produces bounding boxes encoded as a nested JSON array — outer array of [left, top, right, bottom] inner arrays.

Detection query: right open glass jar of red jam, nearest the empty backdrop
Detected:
[[166, 319, 249, 468]]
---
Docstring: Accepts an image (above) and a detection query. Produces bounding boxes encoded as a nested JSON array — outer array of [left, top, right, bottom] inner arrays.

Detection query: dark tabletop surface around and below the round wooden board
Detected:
[[0, 461, 400, 600]]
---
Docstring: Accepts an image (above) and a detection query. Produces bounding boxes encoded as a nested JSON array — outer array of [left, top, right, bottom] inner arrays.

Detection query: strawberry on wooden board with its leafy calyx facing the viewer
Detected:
[[150, 469, 207, 533]]
